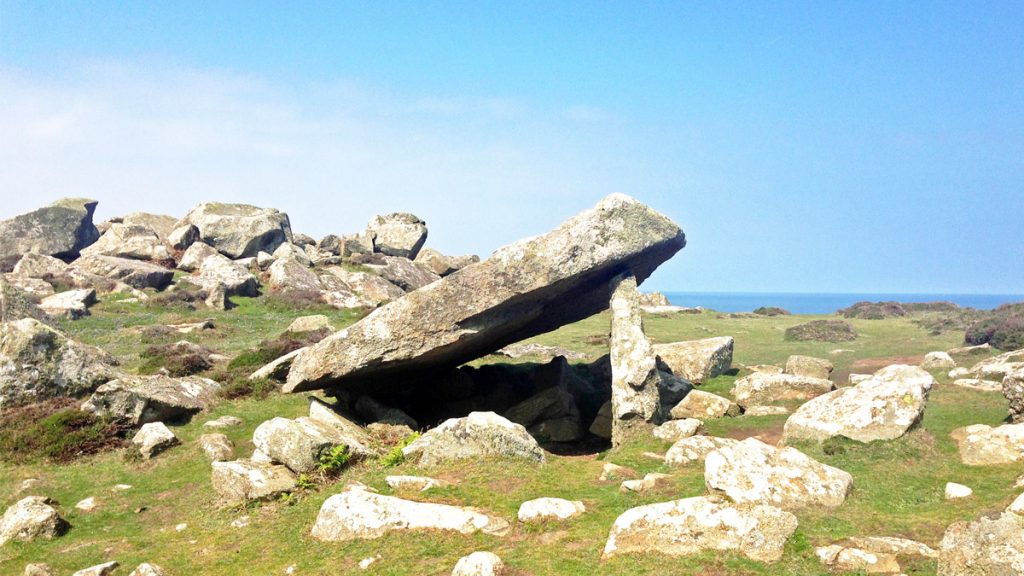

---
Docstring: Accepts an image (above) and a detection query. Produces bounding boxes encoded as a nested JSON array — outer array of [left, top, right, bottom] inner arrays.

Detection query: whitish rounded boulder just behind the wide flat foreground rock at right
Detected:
[[705, 438, 853, 508]]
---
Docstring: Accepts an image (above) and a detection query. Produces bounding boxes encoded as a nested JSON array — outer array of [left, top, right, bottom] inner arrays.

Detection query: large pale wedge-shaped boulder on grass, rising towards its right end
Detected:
[[784, 365, 935, 443]]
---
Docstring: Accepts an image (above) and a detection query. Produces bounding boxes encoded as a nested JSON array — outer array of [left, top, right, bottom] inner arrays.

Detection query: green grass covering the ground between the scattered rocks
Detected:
[[0, 298, 1022, 576]]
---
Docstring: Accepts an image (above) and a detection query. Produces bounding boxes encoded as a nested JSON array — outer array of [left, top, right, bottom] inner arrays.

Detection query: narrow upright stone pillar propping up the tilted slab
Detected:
[[609, 272, 660, 446]]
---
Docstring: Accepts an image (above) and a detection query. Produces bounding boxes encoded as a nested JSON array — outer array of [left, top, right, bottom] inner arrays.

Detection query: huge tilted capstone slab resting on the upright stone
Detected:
[[285, 195, 685, 392]]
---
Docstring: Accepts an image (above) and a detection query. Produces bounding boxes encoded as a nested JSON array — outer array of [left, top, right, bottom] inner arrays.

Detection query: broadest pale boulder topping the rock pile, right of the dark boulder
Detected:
[[178, 202, 292, 258]]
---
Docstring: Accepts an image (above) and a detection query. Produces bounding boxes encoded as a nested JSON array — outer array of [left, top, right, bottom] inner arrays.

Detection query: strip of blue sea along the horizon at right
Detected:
[[665, 292, 1024, 314]]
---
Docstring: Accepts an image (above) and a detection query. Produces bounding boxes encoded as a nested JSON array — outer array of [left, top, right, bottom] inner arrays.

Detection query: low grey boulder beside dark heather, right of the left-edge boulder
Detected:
[[82, 374, 220, 424]]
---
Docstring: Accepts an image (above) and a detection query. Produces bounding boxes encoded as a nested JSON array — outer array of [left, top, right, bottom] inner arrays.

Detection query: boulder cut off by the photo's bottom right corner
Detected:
[[936, 505, 1024, 576]]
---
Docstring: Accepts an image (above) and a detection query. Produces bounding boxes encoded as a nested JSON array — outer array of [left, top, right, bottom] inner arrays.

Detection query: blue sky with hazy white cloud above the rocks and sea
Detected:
[[0, 0, 1024, 293]]
